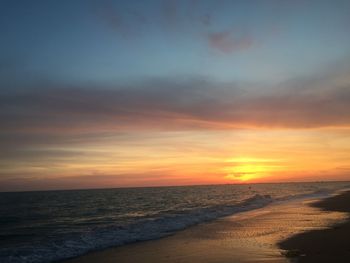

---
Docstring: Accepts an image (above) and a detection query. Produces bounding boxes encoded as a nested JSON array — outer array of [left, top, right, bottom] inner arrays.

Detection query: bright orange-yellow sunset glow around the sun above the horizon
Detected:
[[5, 128, 350, 192]]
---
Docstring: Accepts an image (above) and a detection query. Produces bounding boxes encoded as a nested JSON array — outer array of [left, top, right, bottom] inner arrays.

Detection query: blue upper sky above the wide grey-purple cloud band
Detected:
[[0, 0, 350, 83]]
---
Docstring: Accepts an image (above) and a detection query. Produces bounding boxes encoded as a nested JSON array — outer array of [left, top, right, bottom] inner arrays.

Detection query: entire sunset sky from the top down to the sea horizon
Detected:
[[0, 0, 350, 191]]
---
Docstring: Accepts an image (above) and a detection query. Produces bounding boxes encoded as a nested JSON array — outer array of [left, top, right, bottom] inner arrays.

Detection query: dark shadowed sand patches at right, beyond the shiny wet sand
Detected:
[[279, 191, 350, 263]]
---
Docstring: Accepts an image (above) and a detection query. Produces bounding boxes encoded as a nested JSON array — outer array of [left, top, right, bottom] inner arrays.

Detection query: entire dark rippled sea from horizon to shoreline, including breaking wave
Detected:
[[0, 182, 350, 263]]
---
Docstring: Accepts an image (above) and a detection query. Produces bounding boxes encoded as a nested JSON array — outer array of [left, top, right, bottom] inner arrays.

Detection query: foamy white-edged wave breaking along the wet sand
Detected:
[[0, 190, 330, 263]]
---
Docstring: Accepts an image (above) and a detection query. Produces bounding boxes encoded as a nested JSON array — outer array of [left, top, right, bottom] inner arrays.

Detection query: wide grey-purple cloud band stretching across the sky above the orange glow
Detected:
[[0, 69, 350, 139]]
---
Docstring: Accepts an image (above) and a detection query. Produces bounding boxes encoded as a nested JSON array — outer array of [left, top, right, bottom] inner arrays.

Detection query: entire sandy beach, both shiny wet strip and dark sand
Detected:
[[65, 192, 350, 263]]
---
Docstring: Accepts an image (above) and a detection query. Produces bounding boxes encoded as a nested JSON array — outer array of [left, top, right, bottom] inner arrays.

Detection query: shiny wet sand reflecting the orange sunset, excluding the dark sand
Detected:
[[65, 195, 347, 263]]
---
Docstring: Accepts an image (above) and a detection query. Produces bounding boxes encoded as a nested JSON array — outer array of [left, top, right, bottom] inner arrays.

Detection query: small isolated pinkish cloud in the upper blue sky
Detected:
[[208, 31, 254, 53]]
